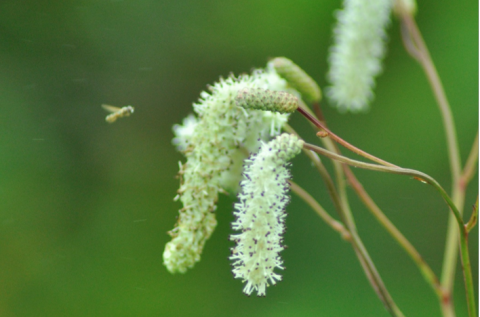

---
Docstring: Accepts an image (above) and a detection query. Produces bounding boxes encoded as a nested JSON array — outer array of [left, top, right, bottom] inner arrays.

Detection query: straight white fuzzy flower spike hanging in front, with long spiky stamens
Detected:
[[230, 133, 304, 296]]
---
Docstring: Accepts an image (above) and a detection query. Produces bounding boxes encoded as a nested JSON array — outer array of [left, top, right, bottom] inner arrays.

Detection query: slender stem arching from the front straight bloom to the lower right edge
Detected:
[[304, 143, 476, 317]]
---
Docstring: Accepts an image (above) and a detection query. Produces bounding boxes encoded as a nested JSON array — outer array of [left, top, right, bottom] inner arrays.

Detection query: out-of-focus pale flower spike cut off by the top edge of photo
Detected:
[[327, 0, 393, 112]]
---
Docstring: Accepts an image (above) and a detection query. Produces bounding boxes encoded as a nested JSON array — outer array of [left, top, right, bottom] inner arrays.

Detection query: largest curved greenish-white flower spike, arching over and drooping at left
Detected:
[[163, 67, 298, 273]]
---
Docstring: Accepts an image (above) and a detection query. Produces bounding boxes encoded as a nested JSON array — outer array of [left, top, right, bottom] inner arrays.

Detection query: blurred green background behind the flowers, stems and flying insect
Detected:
[[0, 0, 478, 317]]
